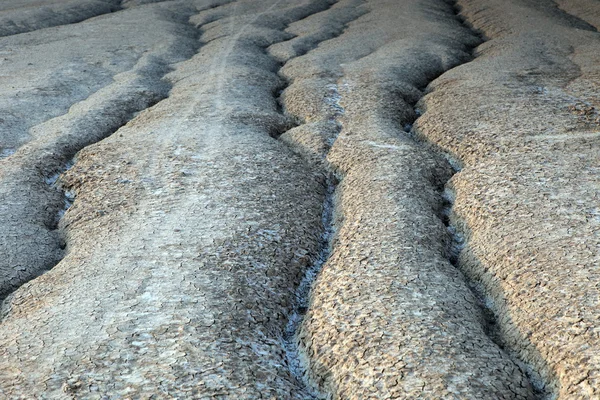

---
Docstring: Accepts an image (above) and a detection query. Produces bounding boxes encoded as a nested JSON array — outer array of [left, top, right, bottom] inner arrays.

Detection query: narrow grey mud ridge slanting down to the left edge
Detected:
[[0, 3, 209, 301]]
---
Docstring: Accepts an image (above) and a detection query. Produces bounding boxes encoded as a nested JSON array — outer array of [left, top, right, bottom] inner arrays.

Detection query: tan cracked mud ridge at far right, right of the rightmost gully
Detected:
[[415, 0, 600, 398]]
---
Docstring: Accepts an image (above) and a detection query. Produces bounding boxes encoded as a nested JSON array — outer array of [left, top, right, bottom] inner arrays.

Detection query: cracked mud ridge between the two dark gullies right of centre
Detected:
[[281, 1, 535, 399]]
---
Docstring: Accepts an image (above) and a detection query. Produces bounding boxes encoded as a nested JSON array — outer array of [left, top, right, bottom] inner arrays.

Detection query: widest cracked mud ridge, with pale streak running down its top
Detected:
[[0, 1, 346, 400]]
